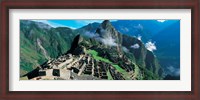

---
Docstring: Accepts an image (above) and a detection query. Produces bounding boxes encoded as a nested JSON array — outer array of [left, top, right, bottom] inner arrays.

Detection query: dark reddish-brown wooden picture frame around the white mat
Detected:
[[0, 0, 200, 100]]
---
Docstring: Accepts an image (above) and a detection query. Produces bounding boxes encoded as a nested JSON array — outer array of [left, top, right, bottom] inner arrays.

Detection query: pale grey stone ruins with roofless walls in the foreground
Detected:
[[24, 54, 125, 80]]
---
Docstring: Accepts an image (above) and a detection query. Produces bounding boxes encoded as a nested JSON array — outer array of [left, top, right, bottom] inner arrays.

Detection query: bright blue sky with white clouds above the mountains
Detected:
[[32, 20, 165, 29]]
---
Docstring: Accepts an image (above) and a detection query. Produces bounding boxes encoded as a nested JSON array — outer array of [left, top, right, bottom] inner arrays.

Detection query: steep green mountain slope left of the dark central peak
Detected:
[[20, 20, 76, 75]]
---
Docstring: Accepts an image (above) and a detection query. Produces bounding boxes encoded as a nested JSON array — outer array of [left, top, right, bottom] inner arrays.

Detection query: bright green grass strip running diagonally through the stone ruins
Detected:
[[87, 50, 130, 80]]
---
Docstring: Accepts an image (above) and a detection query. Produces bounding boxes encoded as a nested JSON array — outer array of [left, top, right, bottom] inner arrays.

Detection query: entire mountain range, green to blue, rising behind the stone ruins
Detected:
[[20, 20, 180, 79]]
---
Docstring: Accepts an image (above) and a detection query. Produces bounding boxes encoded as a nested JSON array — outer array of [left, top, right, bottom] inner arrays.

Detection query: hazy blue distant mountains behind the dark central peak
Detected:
[[74, 20, 180, 77]]
